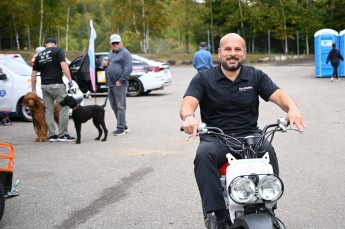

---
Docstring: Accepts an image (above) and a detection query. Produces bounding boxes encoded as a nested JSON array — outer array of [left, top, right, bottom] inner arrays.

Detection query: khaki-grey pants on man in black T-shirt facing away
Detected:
[[41, 84, 69, 137]]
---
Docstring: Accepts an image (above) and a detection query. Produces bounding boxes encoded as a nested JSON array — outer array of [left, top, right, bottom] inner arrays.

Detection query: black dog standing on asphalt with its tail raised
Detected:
[[60, 96, 108, 144]]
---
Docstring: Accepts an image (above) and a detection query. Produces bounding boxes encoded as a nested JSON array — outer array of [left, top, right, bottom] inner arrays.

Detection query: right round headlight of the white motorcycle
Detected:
[[258, 175, 284, 201]]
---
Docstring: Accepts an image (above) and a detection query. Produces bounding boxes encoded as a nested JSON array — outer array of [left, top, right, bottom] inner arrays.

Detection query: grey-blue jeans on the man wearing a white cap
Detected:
[[108, 83, 128, 130]]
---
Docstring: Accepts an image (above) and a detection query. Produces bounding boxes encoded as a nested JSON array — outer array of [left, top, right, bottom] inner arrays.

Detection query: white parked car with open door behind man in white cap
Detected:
[[69, 52, 172, 97]]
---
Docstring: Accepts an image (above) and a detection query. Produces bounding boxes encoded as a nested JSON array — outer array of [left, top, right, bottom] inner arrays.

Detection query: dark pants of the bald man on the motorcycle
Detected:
[[194, 133, 279, 213]]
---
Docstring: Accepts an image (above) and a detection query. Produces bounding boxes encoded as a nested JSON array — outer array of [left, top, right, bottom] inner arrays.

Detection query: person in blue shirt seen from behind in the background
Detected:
[[193, 42, 213, 71]]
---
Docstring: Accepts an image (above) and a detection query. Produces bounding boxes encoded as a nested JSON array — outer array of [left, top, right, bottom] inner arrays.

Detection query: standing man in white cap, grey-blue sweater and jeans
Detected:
[[102, 34, 132, 136]]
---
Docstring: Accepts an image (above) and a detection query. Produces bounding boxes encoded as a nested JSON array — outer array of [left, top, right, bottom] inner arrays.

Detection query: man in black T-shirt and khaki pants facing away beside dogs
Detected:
[[31, 38, 75, 142]]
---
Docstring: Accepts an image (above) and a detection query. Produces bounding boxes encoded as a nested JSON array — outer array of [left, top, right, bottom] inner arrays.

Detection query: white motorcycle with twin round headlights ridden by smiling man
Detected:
[[181, 118, 295, 229]]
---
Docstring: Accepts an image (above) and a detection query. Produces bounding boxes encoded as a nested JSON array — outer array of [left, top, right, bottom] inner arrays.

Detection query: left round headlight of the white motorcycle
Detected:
[[229, 177, 255, 203]]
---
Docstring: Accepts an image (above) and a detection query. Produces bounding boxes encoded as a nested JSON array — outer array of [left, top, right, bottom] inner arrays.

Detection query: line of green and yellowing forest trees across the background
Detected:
[[0, 0, 345, 55]]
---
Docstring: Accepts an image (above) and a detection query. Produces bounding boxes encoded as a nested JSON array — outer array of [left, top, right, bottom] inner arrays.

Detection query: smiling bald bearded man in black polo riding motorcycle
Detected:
[[180, 33, 305, 228]]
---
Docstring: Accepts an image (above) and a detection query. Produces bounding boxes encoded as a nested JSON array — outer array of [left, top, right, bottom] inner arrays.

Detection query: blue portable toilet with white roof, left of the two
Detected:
[[314, 29, 339, 77]]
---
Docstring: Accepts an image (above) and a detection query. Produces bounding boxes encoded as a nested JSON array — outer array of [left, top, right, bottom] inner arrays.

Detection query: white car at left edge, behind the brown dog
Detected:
[[0, 56, 81, 121]]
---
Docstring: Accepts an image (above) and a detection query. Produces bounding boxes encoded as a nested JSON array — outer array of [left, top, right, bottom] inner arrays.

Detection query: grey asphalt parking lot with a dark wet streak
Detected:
[[0, 63, 345, 229]]
